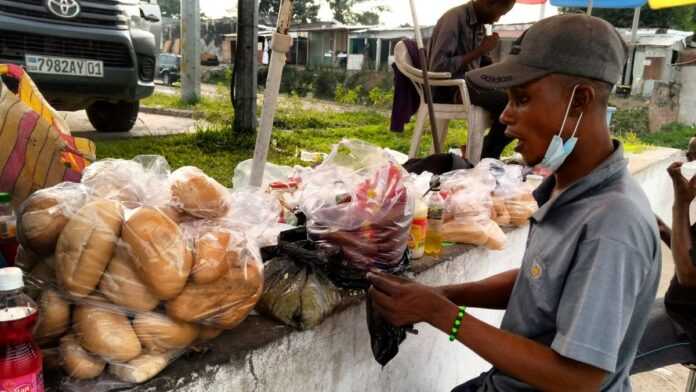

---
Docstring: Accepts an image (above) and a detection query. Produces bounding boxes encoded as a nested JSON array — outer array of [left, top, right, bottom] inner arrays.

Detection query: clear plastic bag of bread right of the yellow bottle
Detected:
[[440, 170, 506, 250]]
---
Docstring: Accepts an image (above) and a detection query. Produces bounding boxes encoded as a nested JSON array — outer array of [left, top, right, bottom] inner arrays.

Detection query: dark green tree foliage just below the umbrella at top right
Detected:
[[564, 5, 696, 31]]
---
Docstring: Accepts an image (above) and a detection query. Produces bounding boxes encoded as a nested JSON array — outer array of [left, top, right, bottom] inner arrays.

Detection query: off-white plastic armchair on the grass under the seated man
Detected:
[[394, 41, 492, 165]]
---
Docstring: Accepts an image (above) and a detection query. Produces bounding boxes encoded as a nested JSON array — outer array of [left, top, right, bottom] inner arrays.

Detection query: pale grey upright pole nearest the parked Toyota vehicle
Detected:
[[181, 0, 201, 103]]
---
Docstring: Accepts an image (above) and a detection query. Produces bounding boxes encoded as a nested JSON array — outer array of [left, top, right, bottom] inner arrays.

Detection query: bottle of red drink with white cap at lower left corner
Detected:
[[0, 267, 44, 392]]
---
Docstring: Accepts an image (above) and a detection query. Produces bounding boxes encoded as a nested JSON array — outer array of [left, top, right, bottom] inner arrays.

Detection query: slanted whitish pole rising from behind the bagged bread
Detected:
[[249, 0, 293, 187]]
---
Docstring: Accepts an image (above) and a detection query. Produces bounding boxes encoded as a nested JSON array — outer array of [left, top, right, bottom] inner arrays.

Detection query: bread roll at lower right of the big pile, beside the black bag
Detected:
[[167, 256, 263, 329]]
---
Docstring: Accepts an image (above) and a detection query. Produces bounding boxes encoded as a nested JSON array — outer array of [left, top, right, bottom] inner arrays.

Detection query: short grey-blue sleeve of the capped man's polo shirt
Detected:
[[551, 238, 649, 373]]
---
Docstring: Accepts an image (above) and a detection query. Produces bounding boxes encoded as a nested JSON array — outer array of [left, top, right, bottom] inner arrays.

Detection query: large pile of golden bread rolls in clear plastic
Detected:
[[18, 160, 263, 383]]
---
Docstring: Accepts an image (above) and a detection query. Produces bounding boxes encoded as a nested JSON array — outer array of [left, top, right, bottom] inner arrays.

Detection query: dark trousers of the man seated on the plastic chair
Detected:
[[433, 84, 513, 159]]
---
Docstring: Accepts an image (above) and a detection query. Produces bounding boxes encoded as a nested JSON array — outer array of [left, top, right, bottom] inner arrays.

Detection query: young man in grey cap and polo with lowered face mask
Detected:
[[368, 15, 660, 391]]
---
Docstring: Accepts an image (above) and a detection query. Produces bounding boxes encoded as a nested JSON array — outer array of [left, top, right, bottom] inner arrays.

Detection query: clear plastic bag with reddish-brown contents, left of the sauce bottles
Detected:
[[301, 140, 414, 270]]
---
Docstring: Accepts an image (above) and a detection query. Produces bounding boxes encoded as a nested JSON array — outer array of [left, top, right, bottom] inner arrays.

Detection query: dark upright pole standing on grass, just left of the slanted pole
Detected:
[[232, 0, 259, 134]]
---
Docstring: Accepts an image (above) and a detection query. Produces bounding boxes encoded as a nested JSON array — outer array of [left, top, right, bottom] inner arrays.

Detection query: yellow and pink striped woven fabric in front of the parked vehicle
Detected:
[[0, 64, 96, 207]]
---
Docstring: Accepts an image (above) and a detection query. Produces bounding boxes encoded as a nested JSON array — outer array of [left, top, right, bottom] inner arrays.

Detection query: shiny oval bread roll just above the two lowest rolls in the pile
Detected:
[[74, 297, 142, 362]]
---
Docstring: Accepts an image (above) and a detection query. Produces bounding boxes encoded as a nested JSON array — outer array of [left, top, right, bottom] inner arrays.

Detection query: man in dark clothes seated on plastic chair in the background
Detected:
[[428, 0, 515, 158]]
